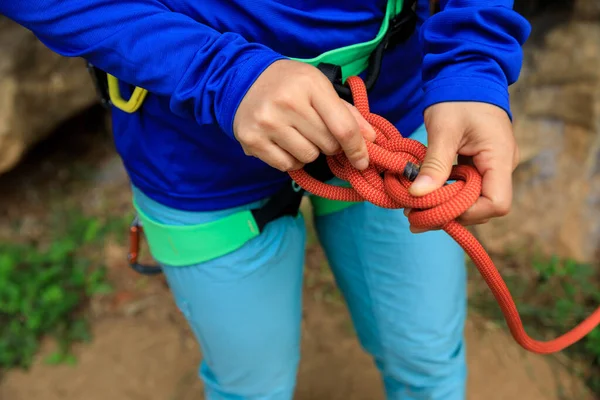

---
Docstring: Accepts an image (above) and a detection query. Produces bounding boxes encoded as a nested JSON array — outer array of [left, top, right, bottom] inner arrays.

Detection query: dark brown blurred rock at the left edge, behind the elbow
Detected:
[[0, 16, 96, 173]]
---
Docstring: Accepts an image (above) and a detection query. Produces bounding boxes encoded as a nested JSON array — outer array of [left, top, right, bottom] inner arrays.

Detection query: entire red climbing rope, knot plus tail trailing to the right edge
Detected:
[[289, 76, 600, 354]]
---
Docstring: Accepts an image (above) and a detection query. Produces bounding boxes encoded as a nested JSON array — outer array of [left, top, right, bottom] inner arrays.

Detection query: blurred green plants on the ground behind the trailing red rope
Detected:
[[470, 256, 600, 394]]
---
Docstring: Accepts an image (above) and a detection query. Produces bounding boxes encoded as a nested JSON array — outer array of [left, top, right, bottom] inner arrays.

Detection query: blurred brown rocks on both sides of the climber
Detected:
[[0, 0, 600, 261]]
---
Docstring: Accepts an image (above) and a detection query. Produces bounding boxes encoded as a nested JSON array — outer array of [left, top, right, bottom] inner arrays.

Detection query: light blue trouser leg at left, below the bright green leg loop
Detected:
[[164, 217, 305, 400]]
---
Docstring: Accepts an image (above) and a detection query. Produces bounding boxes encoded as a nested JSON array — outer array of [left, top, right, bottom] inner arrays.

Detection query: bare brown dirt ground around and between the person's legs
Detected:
[[0, 258, 591, 400]]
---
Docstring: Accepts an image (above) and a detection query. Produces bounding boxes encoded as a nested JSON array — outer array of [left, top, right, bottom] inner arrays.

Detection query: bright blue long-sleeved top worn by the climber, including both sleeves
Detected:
[[0, 0, 530, 210]]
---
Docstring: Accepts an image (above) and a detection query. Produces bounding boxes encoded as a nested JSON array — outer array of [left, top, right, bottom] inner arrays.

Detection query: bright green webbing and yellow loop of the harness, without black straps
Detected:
[[130, 0, 404, 266]]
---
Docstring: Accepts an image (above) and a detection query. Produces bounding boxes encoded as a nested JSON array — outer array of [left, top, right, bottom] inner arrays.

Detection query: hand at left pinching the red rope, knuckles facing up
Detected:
[[233, 60, 375, 172]]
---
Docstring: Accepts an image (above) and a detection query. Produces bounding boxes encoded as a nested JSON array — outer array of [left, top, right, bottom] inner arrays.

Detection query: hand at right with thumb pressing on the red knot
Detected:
[[405, 102, 519, 233]]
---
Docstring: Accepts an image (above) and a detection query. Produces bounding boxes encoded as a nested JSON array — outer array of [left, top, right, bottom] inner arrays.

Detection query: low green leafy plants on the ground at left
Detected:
[[0, 214, 111, 370]]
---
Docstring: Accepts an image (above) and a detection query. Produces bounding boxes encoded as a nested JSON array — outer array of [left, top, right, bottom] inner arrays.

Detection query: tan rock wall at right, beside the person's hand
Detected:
[[475, 6, 600, 262]]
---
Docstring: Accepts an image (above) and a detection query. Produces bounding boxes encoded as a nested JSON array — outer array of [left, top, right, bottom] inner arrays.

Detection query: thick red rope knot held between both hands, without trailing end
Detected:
[[290, 77, 481, 229]]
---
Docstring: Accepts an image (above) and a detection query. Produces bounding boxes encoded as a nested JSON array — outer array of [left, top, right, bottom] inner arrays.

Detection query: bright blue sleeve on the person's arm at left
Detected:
[[0, 0, 283, 136]]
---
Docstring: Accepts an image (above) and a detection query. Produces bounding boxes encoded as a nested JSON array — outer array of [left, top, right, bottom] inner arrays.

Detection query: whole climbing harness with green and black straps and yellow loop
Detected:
[[123, 0, 417, 275]]
